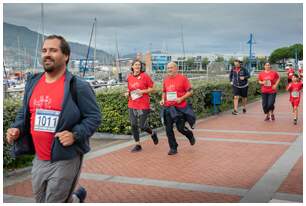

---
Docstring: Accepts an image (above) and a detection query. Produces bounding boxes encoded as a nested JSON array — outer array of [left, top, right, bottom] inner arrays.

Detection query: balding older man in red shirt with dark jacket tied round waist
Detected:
[[160, 62, 195, 155]]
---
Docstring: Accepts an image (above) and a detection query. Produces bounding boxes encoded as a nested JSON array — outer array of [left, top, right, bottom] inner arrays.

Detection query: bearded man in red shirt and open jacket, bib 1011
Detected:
[[6, 35, 101, 202]]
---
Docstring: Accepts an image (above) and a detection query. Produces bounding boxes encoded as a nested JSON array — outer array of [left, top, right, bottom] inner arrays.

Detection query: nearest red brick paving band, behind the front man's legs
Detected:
[[4, 179, 240, 203]]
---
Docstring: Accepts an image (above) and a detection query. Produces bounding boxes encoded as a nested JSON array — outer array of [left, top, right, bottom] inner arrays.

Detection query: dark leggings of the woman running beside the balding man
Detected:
[[129, 108, 153, 142]]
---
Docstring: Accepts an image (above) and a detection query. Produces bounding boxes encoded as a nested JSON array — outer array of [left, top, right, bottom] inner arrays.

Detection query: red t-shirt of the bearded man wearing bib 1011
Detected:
[[29, 74, 65, 160]]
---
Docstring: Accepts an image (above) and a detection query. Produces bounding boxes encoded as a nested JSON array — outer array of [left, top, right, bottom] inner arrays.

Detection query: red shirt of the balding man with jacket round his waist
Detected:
[[163, 74, 191, 108]]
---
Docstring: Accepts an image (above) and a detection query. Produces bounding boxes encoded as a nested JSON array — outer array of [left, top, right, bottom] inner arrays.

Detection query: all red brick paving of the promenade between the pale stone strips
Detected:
[[4, 94, 303, 202]]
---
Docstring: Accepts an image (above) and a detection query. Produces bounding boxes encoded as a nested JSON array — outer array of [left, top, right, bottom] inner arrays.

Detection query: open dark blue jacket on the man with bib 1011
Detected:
[[12, 71, 101, 162]]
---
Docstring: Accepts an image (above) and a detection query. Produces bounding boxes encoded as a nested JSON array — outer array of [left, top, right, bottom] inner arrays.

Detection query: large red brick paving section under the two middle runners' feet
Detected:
[[83, 139, 288, 188]]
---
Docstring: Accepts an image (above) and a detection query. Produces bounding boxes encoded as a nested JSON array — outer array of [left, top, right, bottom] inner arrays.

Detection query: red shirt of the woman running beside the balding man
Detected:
[[127, 72, 154, 110]]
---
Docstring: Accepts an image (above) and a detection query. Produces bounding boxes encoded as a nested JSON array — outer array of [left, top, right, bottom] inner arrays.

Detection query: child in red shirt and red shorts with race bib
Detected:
[[287, 74, 303, 124]]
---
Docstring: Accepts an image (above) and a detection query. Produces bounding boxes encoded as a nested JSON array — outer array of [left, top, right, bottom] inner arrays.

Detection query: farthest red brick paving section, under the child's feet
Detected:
[[196, 93, 303, 132]]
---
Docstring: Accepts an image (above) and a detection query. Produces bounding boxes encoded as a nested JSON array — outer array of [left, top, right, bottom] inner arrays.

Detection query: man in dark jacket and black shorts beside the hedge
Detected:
[[229, 59, 250, 115]]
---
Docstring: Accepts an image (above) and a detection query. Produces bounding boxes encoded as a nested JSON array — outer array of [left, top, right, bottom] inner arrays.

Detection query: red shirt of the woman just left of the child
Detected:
[[258, 70, 279, 94]]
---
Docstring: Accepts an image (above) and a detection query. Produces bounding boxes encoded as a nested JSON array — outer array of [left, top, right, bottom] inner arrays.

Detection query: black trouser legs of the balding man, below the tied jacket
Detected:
[[164, 110, 193, 149]]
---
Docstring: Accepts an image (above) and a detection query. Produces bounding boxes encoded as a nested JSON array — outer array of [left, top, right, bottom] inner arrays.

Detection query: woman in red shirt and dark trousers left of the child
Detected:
[[258, 62, 280, 121]]
